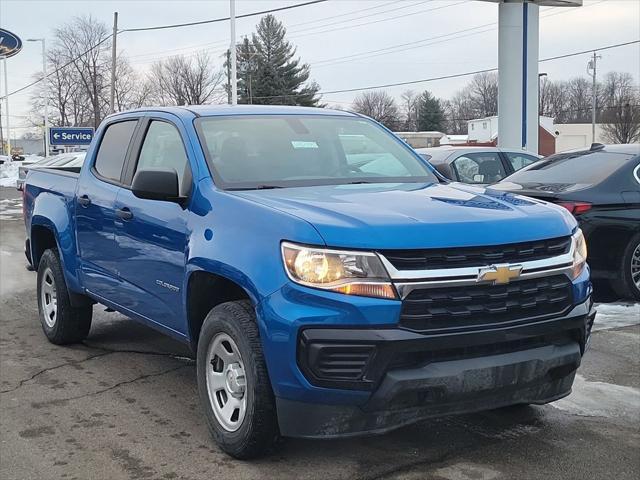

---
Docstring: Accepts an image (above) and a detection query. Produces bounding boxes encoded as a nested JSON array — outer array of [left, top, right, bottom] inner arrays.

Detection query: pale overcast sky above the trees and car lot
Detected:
[[0, 0, 640, 136]]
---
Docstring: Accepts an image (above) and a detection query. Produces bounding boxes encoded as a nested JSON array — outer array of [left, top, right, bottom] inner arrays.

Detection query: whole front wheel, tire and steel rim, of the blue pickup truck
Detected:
[[197, 301, 279, 459]]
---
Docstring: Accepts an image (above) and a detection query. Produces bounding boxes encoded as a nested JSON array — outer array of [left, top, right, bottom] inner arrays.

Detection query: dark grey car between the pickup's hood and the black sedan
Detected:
[[416, 146, 542, 185]]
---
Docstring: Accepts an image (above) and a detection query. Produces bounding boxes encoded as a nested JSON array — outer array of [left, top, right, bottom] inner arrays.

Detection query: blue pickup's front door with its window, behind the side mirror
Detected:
[[115, 119, 192, 334]]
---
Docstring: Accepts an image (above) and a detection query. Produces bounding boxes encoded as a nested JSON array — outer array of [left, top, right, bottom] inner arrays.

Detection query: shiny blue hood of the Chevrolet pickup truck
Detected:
[[234, 183, 576, 249]]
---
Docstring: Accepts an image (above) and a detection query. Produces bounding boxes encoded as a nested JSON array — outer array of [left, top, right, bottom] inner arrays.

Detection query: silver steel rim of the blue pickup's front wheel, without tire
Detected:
[[206, 333, 247, 432]]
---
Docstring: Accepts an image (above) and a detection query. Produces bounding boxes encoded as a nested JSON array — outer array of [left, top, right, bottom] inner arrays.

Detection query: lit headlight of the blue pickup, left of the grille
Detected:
[[282, 242, 397, 299]]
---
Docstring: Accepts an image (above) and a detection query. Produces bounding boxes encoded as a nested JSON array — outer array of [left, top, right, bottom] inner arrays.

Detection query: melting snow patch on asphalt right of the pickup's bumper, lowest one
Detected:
[[551, 375, 640, 423]]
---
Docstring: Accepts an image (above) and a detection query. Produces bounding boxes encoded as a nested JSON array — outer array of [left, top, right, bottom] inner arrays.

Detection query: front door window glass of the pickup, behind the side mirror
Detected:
[[136, 120, 191, 195]]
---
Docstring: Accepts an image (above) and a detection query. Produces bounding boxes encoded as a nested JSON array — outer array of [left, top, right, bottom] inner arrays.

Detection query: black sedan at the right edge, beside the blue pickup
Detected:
[[491, 144, 640, 300]]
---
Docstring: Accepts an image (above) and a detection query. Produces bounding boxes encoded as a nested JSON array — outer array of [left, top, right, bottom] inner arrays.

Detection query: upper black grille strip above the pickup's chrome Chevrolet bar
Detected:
[[380, 237, 571, 270]]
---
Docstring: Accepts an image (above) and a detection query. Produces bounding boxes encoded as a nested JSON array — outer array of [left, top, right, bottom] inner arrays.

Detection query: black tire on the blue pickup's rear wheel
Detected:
[[38, 249, 93, 345]]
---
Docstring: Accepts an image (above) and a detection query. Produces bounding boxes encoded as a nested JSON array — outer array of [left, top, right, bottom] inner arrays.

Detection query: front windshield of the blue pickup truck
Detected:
[[196, 115, 438, 189]]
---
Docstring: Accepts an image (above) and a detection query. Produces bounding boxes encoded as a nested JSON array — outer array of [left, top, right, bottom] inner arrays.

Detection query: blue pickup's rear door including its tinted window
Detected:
[[75, 119, 138, 299]]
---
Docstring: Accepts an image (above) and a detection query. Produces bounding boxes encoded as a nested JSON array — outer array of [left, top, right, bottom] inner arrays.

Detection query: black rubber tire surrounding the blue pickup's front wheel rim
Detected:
[[197, 300, 280, 459]]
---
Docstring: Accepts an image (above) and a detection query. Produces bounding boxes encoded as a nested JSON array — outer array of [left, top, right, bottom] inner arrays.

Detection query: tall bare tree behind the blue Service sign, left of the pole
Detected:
[[55, 16, 110, 128]]
